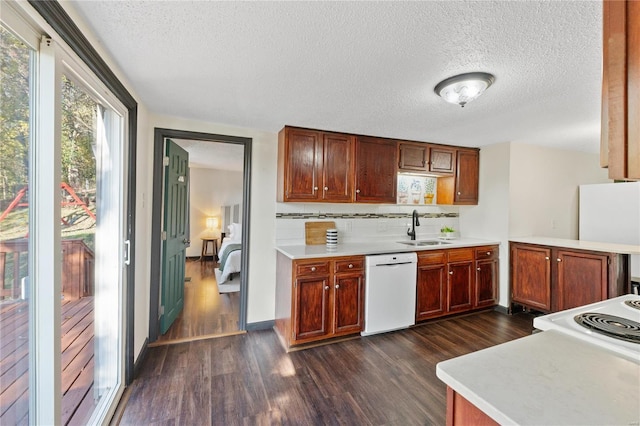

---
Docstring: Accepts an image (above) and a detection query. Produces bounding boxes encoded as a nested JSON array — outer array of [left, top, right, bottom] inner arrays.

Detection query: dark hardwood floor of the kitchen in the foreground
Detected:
[[120, 311, 533, 425]]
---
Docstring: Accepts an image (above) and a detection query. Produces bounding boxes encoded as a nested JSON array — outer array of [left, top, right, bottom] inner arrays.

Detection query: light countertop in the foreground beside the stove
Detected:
[[436, 331, 640, 425]]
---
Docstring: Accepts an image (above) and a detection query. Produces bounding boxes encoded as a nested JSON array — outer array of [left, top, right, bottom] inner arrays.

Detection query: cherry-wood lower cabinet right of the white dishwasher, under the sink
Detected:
[[416, 246, 499, 321]]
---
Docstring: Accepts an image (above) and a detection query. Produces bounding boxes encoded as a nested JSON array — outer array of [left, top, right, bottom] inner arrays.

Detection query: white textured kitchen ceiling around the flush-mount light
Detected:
[[71, 0, 602, 152]]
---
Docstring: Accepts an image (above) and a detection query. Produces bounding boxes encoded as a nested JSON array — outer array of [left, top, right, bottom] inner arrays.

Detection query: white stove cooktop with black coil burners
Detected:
[[533, 294, 640, 363]]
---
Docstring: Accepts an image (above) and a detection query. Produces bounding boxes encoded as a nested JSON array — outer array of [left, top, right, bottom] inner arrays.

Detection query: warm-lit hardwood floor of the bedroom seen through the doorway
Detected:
[[154, 259, 240, 345]]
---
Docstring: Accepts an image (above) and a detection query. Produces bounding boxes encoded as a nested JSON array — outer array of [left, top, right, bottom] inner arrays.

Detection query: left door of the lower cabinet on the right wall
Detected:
[[511, 244, 551, 311]]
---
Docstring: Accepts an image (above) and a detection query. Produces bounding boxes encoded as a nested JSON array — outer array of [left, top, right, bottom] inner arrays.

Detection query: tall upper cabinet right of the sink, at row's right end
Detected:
[[438, 148, 480, 204]]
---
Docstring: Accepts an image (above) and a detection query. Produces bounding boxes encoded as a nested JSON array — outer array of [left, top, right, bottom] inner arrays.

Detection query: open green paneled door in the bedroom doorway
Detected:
[[160, 139, 189, 334]]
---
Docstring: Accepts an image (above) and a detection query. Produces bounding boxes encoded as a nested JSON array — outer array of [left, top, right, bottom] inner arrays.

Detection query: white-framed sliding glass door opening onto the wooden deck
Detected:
[[0, 2, 129, 425]]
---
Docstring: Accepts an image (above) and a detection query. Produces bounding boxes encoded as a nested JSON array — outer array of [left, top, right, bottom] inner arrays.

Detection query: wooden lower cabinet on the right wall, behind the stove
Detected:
[[510, 242, 630, 312]]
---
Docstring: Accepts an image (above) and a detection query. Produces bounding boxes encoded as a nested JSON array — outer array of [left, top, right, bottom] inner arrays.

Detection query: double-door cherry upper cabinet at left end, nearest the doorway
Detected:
[[277, 127, 354, 202]]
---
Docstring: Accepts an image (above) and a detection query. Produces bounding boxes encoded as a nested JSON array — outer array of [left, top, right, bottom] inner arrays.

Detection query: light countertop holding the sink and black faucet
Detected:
[[276, 238, 500, 259]]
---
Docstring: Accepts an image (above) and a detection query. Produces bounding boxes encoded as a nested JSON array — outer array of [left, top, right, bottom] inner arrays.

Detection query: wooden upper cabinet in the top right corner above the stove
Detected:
[[600, 0, 640, 180]]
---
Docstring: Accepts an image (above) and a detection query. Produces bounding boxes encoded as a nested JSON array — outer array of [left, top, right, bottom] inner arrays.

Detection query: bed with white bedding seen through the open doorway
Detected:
[[215, 223, 242, 293]]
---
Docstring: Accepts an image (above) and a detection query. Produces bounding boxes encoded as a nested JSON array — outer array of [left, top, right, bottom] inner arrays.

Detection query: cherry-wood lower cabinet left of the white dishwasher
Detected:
[[276, 253, 364, 347]]
